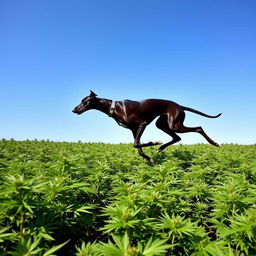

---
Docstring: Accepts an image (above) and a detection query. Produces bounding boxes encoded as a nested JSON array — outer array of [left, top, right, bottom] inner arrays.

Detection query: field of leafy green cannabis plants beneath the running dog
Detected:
[[0, 140, 256, 256]]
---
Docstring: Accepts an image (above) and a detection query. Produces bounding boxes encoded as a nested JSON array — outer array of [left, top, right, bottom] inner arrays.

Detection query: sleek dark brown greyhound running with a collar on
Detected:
[[72, 91, 221, 164]]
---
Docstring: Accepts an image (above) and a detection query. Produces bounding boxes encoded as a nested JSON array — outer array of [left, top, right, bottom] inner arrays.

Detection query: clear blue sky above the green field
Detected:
[[0, 0, 256, 144]]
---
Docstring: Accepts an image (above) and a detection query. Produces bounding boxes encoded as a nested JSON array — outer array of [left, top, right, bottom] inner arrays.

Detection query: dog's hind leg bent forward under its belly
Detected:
[[156, 115, 181, 153]]
